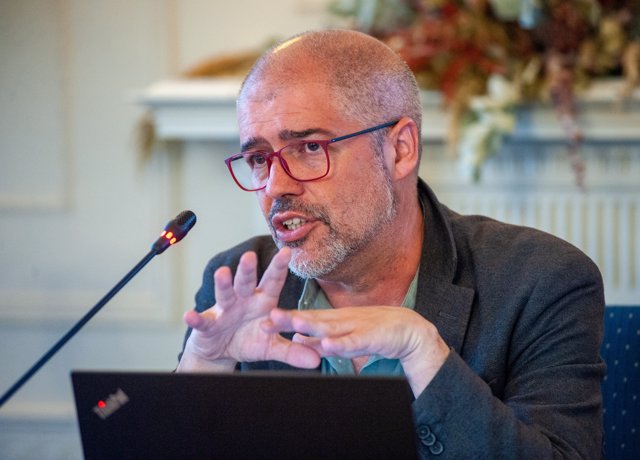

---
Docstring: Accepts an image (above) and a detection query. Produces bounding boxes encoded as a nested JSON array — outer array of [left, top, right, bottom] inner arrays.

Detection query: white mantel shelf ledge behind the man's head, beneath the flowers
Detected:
[[139, 78, 640, 142]]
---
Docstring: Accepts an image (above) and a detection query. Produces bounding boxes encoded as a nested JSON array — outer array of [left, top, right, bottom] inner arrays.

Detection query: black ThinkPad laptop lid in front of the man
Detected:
[[71, 371, 417, 460]]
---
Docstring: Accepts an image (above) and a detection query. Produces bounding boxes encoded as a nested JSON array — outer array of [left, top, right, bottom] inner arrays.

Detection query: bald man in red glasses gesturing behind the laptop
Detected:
[[178, 30, 604, 459]]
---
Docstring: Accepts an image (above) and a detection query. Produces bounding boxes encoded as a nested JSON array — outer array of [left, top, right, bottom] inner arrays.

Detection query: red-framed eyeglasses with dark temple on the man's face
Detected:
[[224, 120, 398, 192]]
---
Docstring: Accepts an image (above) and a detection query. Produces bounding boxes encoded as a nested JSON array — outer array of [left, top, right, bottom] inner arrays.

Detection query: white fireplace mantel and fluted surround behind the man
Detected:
[[135, 79, 640, 305]]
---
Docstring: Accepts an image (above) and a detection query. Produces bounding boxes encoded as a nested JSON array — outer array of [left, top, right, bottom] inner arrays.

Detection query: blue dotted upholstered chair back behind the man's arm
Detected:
[[602, 307, 640, 460]]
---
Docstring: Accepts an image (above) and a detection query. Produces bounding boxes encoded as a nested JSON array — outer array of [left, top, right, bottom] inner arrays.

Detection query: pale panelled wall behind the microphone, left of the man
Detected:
[[0, 0, 336, 459]]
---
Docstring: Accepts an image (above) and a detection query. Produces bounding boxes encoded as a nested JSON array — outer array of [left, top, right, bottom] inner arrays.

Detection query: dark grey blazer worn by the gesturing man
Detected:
[[187, 180, 605, 459]]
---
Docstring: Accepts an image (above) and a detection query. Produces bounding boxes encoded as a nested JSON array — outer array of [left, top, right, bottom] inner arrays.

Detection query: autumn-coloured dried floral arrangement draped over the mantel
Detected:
[[330, 0, 640, 186]]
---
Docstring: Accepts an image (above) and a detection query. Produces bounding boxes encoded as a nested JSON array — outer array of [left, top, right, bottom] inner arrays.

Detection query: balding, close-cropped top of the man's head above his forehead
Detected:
[[238, 30, 422, 145]]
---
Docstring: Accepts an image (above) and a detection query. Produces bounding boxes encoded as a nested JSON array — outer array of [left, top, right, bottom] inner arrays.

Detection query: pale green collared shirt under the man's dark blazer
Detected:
[[298, 272, 418, 376]]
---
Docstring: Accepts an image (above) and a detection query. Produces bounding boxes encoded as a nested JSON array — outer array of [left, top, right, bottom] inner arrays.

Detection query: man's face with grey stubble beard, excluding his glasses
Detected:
[[238, 83, 396, 279]]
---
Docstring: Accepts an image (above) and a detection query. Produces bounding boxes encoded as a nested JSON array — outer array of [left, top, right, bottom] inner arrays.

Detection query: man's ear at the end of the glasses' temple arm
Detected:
[[388, 117, 421, 180]]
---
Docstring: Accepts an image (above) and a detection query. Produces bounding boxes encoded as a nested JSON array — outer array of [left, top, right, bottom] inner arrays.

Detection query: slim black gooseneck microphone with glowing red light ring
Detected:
[[0, 210, 196, 407]]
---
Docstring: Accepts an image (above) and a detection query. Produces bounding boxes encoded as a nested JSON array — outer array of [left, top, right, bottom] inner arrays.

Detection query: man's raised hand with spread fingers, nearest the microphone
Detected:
[[177, 248, 320, 372]]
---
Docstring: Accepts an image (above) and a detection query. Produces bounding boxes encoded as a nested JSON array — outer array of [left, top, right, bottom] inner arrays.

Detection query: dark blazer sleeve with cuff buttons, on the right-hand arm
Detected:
[[413, 246, 604, 459]]
